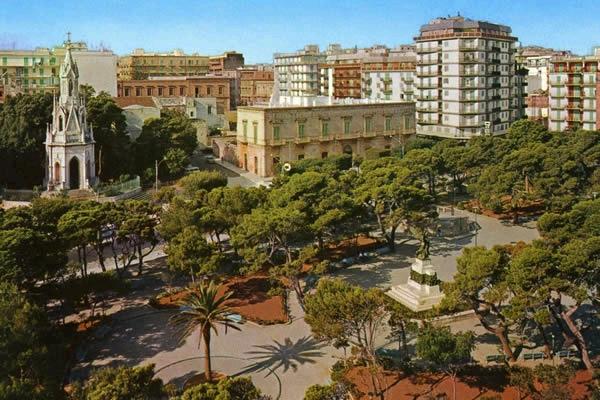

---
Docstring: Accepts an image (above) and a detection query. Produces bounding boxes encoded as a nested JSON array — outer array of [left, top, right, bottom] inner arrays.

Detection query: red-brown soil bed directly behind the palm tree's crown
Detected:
[[150, 275, 288, 325]]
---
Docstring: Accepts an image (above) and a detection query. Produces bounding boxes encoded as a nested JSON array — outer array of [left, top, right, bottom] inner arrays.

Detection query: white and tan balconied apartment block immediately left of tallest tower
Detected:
[[362, 46, 416, 101]]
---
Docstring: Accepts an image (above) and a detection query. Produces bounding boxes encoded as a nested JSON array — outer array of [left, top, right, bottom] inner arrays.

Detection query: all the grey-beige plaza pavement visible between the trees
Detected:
[[73, 210, 538, 400]]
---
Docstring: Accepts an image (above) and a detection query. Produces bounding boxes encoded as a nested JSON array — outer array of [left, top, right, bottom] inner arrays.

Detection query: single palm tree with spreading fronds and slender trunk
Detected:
[[169, 281, 240, 381]]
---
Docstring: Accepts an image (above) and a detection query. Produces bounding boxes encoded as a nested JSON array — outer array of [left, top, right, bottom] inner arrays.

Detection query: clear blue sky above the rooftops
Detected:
[[0, 0, 600, 63]]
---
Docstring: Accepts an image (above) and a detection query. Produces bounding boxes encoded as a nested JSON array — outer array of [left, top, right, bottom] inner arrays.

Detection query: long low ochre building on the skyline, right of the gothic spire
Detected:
[[118, 49, 210, 81]]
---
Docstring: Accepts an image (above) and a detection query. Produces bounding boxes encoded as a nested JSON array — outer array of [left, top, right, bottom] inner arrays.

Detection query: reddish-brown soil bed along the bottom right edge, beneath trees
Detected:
[[346, 367, 591, 400]]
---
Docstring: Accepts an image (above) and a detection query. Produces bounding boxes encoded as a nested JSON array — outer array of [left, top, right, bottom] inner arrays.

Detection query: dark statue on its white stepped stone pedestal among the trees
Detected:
[[386, 235, 444, 312]]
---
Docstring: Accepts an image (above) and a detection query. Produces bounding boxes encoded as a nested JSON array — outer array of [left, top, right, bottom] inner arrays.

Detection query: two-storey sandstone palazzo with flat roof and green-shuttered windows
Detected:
[[236, 98, 415, 177]]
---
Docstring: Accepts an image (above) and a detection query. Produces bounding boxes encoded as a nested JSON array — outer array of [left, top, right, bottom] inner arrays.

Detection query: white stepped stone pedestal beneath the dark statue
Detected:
[[386, 258, 444, 312]]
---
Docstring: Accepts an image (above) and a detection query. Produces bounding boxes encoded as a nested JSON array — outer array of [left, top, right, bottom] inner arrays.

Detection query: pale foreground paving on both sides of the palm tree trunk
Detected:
[[73, 293, 343, 400]]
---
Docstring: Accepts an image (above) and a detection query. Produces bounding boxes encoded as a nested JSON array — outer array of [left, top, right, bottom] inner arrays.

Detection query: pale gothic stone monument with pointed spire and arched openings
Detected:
[[45, 39, 96, 192]]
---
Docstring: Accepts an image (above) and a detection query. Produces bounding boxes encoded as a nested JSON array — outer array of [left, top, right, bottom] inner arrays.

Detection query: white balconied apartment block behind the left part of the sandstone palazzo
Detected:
[[273, 45, 327, 97]]
